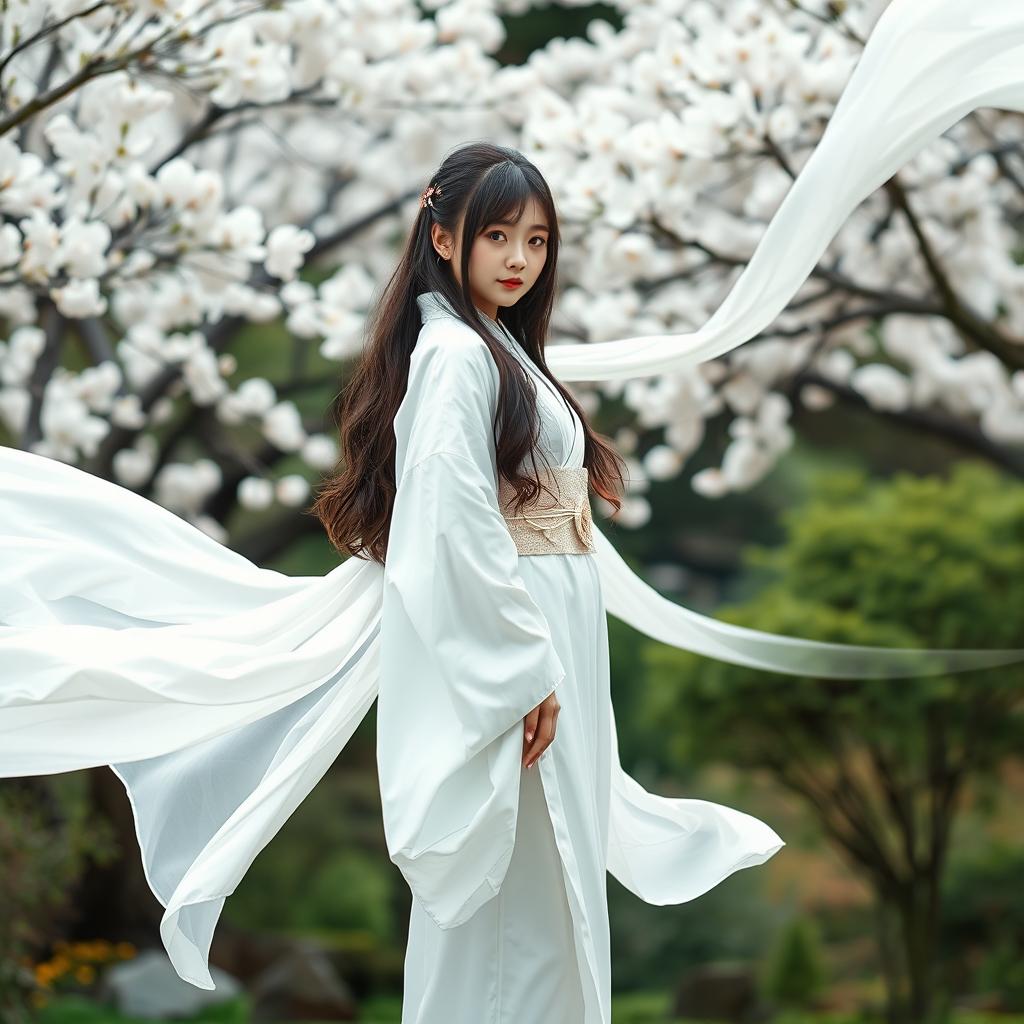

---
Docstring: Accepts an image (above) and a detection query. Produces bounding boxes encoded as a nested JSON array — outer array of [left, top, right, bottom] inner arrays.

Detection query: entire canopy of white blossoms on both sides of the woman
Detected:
[[0, 0, 1024, 557]]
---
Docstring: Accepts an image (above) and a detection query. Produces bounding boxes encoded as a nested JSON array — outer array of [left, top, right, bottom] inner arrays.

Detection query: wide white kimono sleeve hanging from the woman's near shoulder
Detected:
[[377, 321, 565, 927]]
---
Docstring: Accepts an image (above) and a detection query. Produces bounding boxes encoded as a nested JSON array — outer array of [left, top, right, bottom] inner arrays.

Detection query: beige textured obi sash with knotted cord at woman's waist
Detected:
[[498, 466, 594, 555]]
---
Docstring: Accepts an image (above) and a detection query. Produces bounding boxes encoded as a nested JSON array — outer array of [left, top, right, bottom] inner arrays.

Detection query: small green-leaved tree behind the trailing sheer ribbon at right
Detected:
[[644, 464, 1024, 1022]]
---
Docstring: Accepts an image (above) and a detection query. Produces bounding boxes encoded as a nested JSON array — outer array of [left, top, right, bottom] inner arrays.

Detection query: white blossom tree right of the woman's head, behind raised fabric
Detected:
[[523, 2, 1024, 522]]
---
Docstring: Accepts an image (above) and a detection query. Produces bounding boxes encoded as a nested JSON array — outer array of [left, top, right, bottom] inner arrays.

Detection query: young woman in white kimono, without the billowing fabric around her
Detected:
[[314, 144, 634, 1024]]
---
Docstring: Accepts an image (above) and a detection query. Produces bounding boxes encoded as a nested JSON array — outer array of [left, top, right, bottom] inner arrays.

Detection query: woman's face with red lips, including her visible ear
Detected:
[[434, 198, 549, 319]]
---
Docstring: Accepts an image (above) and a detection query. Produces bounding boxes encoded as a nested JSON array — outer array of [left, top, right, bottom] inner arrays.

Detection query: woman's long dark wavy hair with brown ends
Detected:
[[310, 142, 625, 564]]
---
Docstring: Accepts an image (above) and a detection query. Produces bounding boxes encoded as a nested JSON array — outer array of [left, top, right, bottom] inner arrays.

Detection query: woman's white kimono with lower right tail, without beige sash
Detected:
[[377, 293, 783, 1024]]
